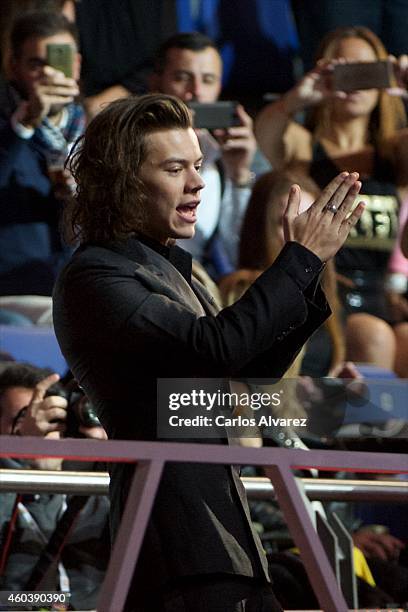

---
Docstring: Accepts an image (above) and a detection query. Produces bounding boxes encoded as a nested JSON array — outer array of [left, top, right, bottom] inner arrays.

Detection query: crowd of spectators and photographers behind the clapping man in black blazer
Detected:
[[0, 0, 408, 609]]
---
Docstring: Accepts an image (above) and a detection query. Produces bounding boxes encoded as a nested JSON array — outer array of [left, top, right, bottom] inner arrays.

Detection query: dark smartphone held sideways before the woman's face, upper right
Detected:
[[333, 60, 394, 91]]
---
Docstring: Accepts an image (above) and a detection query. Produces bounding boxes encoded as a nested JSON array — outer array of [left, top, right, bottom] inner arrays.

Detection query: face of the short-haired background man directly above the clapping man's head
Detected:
[[153, 47, 222, 102]]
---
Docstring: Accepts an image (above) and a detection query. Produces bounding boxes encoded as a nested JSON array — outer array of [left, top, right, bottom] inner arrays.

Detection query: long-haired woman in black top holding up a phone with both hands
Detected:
[[255, 27, 408, 376]]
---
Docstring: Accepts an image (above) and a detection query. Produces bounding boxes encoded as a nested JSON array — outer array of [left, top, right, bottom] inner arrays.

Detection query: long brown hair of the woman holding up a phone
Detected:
[[307, 26, 407, 157]]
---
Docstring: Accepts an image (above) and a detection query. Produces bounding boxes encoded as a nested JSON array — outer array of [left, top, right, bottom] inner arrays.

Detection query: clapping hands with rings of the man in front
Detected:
[[283, 172, 364, 261]]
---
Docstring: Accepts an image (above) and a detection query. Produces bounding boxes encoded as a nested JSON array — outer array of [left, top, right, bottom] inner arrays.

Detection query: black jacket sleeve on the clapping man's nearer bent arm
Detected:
[[56, 243, 330, 376]]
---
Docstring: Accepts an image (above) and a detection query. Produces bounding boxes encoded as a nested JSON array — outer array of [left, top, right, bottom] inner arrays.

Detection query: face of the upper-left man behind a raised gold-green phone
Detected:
[[10, 32, 80, 96]]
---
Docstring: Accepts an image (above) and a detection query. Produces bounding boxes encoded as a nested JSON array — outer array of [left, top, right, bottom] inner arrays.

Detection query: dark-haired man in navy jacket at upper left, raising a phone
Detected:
[[0, 12, 84, 320]]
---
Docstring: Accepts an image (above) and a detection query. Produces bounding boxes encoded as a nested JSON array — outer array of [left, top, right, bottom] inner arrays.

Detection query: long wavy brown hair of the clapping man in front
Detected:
[[64, 94, 192, 243]]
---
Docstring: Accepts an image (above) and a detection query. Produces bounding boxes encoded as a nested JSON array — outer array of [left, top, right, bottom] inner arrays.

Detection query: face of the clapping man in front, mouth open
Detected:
[[139, 128, 204, 244]]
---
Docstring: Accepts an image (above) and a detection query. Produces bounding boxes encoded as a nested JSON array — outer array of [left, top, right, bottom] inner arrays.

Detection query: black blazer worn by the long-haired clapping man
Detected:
[[54, 238, 330, 584]]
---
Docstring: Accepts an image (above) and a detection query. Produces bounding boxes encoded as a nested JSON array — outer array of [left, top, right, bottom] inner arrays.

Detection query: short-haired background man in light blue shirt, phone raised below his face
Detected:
[[151, 32, 256, 277]]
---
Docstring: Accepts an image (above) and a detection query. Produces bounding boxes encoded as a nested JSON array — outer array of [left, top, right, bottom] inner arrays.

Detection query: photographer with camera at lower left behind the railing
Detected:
[[0, 363, 109, 609]]
